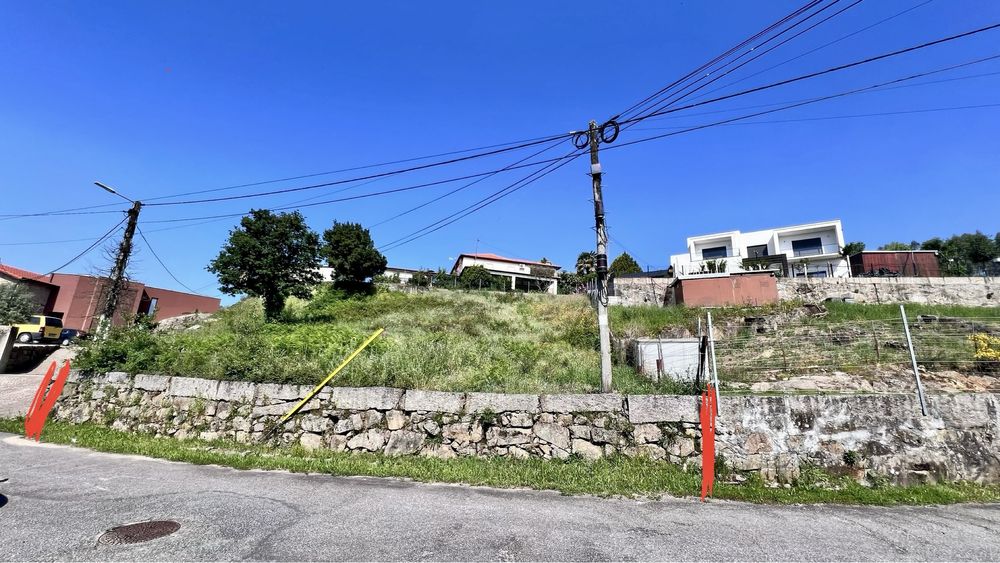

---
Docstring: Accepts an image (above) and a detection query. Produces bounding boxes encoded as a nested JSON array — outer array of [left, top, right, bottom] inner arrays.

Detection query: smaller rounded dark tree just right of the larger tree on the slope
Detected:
[[320, 221, 387, 283]]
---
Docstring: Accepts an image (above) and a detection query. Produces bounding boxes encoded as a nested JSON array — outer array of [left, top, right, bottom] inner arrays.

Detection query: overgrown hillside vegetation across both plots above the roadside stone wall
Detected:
[[76, 286, 1000, 393]]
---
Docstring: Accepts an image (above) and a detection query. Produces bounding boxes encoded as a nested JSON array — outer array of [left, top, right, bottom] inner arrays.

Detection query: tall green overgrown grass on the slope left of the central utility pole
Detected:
[[76, 285, 673, 393]]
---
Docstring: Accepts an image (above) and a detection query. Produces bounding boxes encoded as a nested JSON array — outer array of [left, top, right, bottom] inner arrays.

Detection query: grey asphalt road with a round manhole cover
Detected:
[[0, 434, 1000, 560]]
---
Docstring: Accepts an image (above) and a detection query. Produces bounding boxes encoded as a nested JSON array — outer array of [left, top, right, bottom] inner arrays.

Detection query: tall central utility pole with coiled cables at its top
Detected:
[[587, 121, 617, 393]]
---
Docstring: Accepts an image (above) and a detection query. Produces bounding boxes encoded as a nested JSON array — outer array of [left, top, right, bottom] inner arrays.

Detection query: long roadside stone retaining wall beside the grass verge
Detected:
[[54, 373, 1000, 482]]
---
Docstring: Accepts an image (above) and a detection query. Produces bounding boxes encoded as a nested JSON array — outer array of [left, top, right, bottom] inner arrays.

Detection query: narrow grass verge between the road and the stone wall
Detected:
[[0, 419, 1000, 505]]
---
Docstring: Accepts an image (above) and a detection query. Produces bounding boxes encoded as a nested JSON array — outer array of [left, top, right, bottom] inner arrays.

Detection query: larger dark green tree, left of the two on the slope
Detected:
[[208, 209, 320, 320]]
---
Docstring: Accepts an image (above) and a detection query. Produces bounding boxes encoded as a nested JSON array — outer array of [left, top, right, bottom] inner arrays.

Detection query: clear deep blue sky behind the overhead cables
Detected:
[[0, 0, 1000, 304]]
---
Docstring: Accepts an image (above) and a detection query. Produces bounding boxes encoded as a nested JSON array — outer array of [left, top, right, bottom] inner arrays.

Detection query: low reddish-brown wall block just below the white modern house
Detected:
[[674, 274, 778, 307]]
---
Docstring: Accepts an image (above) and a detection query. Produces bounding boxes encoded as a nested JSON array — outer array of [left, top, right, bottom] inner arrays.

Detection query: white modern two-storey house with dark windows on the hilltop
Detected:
[[670, 219, 850, 278]]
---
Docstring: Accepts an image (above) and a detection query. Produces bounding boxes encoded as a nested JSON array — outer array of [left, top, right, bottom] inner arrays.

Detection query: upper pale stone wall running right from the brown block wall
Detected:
[[778, 278, 1000, 307]]
